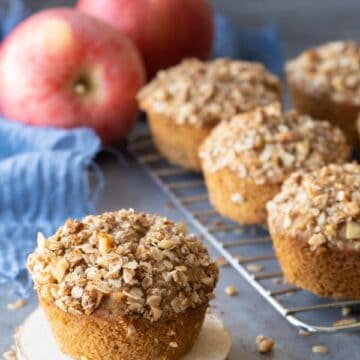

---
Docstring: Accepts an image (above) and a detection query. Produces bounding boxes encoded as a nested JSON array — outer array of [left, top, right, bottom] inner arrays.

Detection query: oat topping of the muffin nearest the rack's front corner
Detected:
[[267, 163, 360, 250]]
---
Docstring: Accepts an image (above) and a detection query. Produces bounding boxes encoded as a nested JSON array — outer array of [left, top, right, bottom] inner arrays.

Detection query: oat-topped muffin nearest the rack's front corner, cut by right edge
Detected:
[[267, 163, 360, 299]]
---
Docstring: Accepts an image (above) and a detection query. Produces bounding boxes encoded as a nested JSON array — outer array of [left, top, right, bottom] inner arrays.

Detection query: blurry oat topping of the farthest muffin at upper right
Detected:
[[286, 41, 360, 105]]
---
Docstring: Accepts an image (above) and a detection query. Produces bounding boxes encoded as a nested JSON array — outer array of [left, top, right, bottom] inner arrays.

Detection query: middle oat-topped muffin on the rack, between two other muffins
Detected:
[[200, 103, 350, 224]]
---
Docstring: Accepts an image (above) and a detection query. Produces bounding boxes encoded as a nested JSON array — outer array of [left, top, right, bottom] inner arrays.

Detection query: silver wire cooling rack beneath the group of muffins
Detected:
[[129, 132, 360, 333]]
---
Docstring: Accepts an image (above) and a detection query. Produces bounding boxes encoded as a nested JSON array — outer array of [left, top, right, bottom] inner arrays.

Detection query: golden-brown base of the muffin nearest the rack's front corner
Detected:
[[269, 226, 360, 300]]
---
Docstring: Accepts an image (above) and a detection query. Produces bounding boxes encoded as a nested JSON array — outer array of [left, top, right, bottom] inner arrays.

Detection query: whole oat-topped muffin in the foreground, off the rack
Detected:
[[28, 210, 218, 360]]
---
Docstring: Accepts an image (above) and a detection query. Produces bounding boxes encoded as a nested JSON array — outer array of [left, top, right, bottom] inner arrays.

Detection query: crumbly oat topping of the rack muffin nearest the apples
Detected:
[[138, 59, 280, 127]]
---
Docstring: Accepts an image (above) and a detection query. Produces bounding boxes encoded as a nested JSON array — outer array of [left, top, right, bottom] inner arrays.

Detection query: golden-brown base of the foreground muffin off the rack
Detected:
[[40, 299, 207, 360]]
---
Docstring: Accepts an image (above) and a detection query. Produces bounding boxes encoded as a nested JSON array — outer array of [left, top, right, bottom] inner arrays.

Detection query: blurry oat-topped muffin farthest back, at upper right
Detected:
[[286, 41, 360, 147]]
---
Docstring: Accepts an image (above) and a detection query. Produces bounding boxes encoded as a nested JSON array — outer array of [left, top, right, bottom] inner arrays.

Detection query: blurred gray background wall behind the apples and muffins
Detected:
[[17, 0, 360, 57]]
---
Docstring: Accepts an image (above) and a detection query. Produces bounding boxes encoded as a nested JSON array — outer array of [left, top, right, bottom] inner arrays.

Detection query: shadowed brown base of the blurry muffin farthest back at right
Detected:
[[288, 80, 360, 148]]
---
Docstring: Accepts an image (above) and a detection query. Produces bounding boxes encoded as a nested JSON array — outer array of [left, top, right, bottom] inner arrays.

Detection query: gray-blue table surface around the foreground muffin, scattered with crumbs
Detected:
[[0, 153, 360, 360]]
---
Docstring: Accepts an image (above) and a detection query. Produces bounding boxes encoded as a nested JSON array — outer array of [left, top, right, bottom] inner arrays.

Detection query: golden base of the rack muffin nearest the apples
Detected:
[[147, 112, 212, 171]]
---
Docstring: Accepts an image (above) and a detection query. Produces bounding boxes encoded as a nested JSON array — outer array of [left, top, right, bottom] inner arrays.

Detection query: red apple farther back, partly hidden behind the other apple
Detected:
[[77, 0, 214, 78]]
